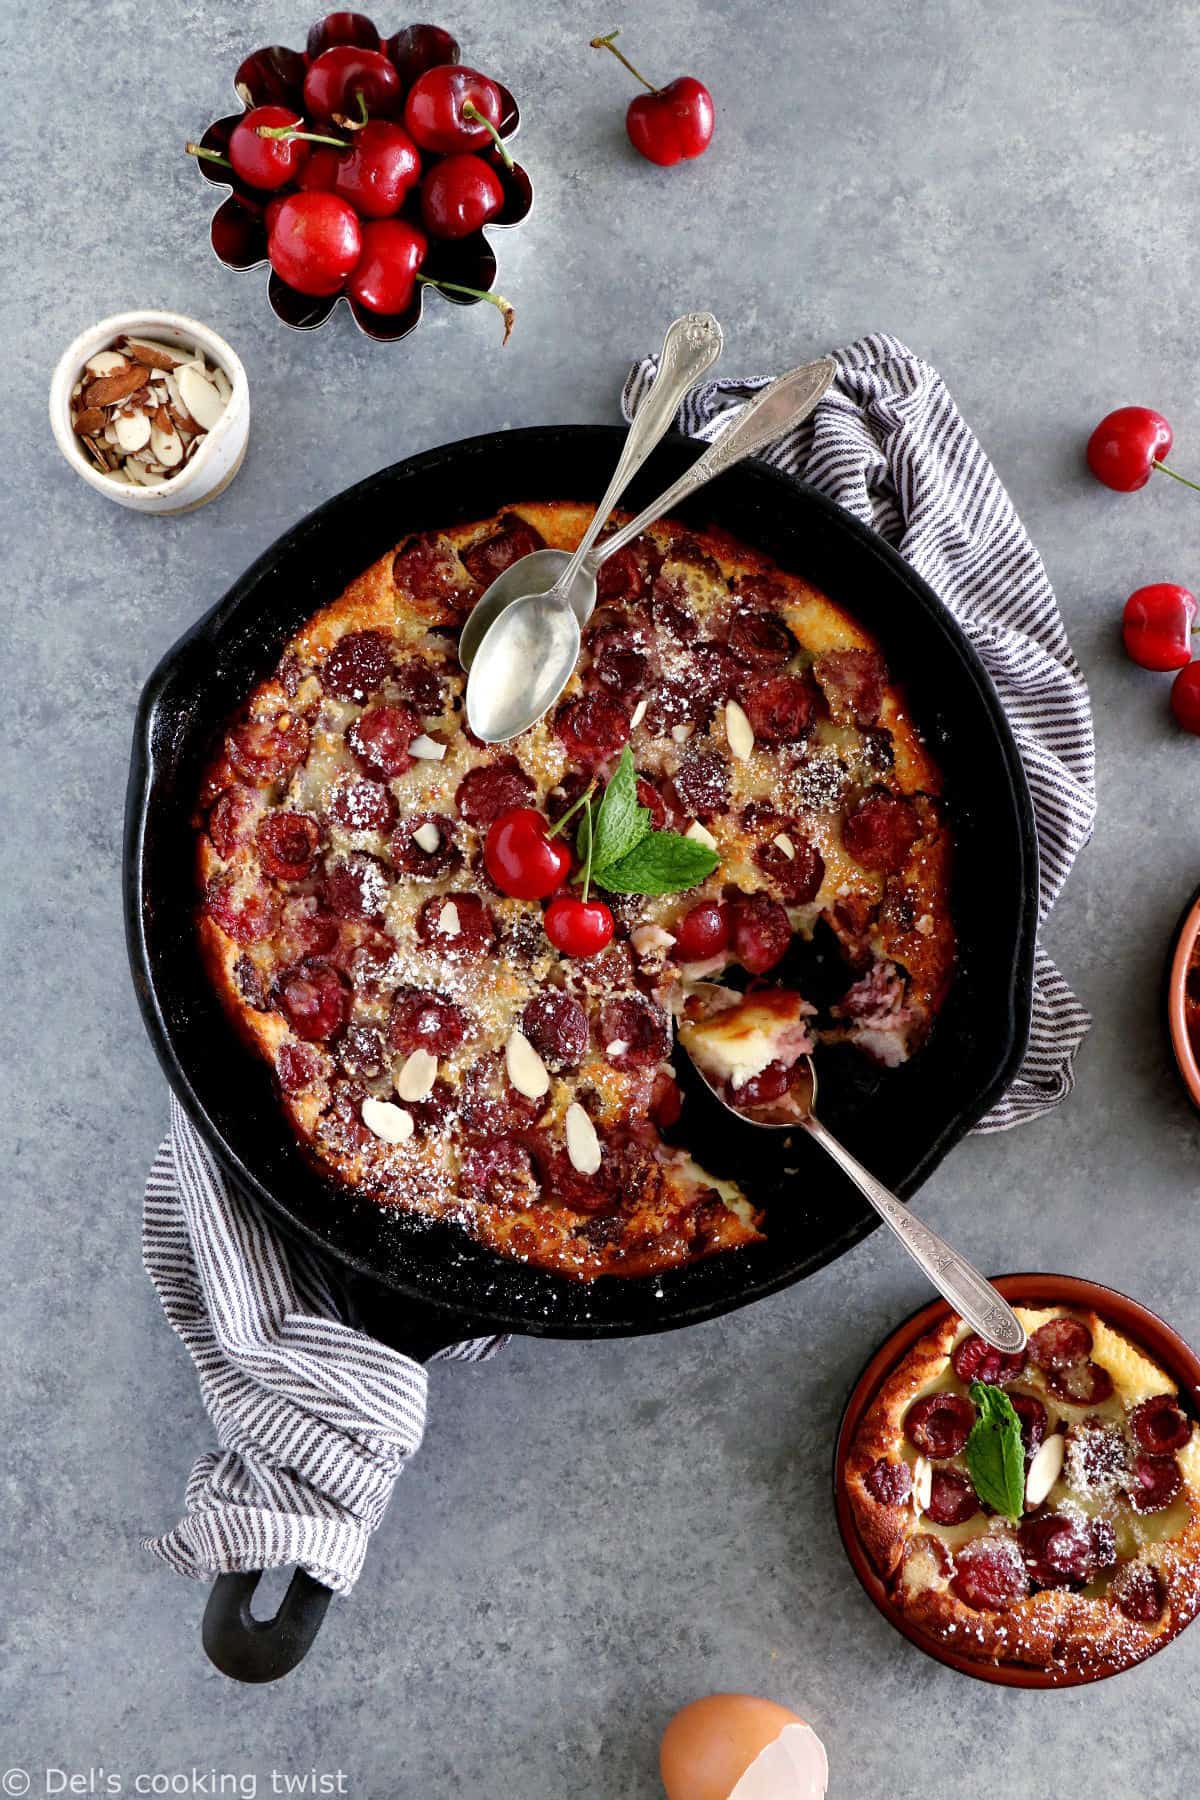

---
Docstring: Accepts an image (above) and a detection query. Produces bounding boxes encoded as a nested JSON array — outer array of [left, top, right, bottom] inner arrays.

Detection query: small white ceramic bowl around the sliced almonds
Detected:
[[50, 313, 250, 515]]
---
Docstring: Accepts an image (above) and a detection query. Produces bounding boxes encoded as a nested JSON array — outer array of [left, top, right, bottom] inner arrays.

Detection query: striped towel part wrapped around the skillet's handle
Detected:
[[142, 1096, 506, 1593]]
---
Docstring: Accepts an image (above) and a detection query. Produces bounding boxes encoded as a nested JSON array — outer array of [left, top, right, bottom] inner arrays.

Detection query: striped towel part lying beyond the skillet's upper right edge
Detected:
[[622, 337, 1096, 1132]]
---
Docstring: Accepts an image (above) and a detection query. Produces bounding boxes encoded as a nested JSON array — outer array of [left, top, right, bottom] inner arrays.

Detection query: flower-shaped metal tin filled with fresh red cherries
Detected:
[[187, 13, 533, 342]]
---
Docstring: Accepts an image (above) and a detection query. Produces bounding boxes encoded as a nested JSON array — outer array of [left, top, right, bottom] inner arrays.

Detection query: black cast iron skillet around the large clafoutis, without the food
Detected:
[[124, 425, 1036, 1679]]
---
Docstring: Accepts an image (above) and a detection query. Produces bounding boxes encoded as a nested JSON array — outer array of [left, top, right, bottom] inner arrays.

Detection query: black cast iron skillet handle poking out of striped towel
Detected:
[[201, 1273, 477, 1681]]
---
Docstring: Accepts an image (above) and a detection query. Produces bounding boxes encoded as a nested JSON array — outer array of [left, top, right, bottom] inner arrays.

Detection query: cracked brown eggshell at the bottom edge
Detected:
[[658, 1694, 828, 1800]]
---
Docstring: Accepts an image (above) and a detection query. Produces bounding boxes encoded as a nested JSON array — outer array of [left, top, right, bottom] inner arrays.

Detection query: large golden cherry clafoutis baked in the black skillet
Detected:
[[196, 502, 954, 1278]]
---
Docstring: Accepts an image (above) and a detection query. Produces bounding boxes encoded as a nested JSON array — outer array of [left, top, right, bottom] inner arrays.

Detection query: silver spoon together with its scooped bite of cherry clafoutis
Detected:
[[678, 983, 1025, 1352]]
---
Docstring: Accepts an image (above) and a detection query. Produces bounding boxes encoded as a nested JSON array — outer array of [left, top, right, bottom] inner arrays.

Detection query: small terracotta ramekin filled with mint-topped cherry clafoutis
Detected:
[[835, 1276, 1200, 1687]]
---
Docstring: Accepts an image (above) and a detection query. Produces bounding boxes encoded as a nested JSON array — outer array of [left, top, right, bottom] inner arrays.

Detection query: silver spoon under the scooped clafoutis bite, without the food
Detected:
[[680, 1026, 1025, 1354]]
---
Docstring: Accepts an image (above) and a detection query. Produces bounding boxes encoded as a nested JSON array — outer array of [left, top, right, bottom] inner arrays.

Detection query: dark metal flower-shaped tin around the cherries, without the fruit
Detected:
[[196, 13, 533, 344]]
